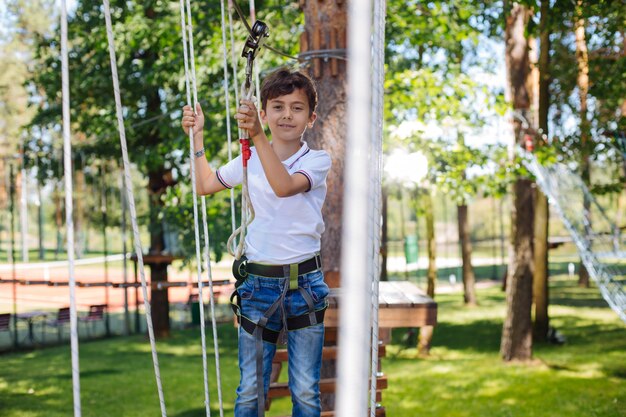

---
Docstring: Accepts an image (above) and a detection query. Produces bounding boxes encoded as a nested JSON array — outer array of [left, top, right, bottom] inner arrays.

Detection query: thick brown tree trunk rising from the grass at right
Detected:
[[500, 2, 534, 361]]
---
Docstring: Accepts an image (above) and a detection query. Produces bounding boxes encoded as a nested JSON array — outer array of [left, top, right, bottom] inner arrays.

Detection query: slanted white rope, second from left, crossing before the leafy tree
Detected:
[[103, 0, 167, 417]]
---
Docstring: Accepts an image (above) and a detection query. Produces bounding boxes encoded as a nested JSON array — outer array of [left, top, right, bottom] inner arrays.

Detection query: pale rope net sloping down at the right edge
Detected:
[[523, 153, 626, 323]]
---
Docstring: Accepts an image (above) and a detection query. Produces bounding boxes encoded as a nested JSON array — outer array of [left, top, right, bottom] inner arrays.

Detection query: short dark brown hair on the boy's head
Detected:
[[261, 67, 317, 116]]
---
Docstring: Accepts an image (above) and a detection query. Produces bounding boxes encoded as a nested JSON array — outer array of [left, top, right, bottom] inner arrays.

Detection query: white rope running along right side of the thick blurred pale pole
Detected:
[[368, 0, 386, 417]]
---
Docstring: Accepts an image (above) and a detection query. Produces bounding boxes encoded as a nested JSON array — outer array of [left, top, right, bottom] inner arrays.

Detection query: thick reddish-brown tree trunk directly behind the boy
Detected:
[[300, 0, 348, 410]]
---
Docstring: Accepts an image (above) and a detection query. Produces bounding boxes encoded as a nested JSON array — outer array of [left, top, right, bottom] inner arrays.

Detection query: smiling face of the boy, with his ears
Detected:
[[261, 89, 317, 141]]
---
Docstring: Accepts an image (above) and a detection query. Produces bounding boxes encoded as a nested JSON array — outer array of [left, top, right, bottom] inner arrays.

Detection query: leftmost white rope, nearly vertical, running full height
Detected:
[[61, 0, 81, 417]]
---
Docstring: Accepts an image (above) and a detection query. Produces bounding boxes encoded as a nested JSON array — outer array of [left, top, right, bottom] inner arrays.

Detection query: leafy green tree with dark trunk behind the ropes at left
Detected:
[[28, 0, 298, 336]]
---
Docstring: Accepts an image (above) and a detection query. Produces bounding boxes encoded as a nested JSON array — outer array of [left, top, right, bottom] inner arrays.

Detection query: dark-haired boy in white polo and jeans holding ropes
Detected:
[[182, 68, 331, 417]]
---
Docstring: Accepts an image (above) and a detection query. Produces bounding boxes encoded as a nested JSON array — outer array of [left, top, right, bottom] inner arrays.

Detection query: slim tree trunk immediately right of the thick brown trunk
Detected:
[[533, 0, 551, 341]]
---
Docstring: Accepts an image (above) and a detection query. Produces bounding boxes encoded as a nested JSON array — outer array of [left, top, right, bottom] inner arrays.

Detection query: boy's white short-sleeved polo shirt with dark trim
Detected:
[[216, 143, 331, 265]]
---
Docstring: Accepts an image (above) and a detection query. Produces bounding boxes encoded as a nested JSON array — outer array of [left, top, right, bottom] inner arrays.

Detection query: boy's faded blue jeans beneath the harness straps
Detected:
[[235, 271, 328, 417]]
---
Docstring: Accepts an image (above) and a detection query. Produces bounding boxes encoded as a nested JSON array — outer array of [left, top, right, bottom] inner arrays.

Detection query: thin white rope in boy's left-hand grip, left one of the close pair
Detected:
[[180, 0, 211, 417]]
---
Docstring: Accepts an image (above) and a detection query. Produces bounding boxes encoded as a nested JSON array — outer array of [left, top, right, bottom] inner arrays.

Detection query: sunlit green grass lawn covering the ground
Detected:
[[0, 279, 626, 417]]
